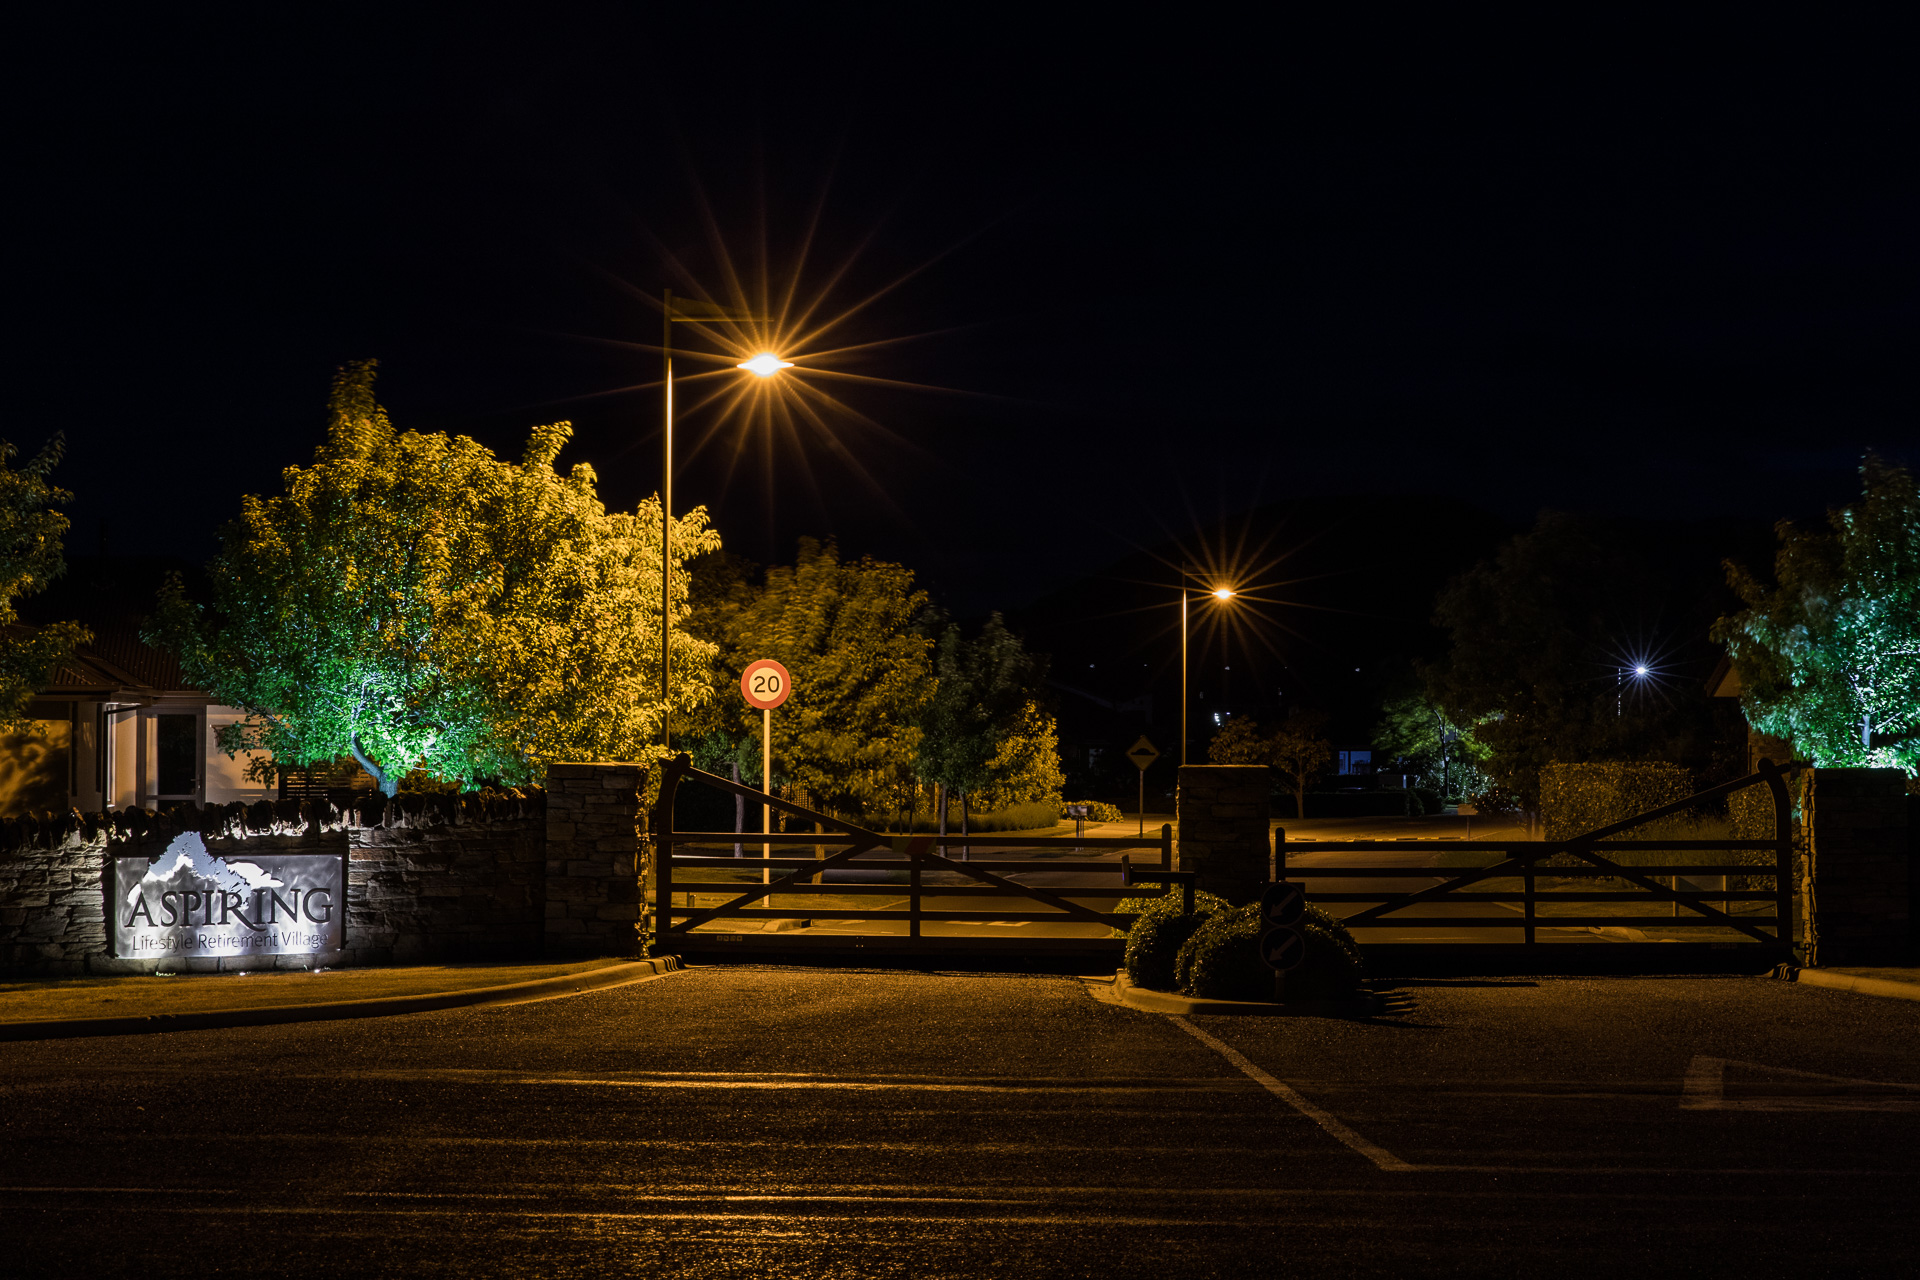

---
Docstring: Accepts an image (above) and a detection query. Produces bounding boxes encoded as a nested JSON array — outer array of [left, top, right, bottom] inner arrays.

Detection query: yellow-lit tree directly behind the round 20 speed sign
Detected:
[[695, 537, 933, 814]]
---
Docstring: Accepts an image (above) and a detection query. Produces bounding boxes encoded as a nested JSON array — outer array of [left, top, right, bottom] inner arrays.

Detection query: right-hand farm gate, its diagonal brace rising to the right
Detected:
[[1275, 760, 1805, 973]]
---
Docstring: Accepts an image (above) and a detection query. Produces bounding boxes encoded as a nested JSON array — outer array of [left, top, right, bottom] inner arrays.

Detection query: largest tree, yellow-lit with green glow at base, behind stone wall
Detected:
[[150, 361, 718, 794]]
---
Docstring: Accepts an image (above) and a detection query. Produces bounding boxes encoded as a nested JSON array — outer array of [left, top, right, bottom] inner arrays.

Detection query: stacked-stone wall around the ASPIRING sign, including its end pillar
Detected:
[[0, 764, 645, 977]]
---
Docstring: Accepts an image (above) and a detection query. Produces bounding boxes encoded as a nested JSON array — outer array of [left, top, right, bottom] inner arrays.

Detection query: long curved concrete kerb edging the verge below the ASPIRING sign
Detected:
[[0, 956, 684, 1040]]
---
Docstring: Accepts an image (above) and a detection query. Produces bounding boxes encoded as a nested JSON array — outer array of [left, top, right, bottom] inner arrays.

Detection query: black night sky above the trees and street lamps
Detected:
[[0, 6, 1920, 612]]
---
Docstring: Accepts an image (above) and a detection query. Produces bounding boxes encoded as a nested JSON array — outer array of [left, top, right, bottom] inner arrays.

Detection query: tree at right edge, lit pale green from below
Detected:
[[1713, 455, 1920, 775]]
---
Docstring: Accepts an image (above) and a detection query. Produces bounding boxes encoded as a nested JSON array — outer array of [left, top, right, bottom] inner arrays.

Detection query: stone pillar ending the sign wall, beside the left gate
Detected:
[[543, 762, 647, 956]]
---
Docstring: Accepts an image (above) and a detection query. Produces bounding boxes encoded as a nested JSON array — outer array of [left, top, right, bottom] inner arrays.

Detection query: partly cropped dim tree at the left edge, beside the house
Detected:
[[0, 434, 92, 729]]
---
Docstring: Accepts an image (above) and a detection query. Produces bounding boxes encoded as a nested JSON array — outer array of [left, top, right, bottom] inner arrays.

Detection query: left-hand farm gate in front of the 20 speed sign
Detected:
[[653, 756, 1192, 971]]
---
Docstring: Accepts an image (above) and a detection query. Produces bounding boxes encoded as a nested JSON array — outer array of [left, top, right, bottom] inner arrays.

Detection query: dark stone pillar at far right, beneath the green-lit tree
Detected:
[[1803, 770, 1914, 965]]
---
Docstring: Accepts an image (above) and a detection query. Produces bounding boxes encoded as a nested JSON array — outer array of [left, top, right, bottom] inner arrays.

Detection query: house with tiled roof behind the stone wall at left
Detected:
[[0, 620, 280, 818]]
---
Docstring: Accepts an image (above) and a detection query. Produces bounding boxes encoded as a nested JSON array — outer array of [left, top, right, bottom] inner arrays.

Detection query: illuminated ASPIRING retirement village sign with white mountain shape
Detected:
[[108, 831, 348, 960]]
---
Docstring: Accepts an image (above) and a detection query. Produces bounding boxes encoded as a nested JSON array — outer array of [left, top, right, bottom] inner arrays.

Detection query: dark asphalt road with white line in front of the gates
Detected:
[[0, 969, 1920, 1280]]
